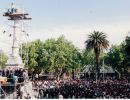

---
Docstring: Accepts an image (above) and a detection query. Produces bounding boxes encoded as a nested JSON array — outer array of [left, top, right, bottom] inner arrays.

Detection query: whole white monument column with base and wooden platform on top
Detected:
[[3, 3, 31, 68]]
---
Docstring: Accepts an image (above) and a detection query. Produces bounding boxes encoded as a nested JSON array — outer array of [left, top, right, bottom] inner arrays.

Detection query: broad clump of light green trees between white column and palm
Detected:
[[22, 36, 82, 79]]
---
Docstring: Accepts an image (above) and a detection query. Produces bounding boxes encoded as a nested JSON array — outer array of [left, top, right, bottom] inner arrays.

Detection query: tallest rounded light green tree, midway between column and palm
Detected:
[[44, 36, 80, 78]]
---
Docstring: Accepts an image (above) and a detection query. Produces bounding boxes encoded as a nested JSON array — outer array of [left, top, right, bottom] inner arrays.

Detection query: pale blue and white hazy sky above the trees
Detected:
[[0, 0, 130, 53]]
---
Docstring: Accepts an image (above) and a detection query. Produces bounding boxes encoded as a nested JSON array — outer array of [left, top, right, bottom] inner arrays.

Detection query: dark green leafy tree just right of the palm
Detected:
[[105, 45, 125, 77]]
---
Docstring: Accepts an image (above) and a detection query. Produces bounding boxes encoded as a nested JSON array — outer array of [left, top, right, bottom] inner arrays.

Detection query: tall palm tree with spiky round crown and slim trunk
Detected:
[[85, 31, 109, 79]]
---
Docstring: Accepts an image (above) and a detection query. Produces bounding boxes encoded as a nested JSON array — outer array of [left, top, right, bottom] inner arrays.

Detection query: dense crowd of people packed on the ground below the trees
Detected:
[[33, 79, 130, 99]]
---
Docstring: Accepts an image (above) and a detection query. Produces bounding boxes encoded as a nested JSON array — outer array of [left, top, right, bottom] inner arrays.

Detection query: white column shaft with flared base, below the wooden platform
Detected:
[[6, 20, 24, 68]]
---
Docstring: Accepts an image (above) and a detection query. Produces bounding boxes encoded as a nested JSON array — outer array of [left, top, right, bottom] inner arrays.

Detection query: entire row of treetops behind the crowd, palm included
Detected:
[[22, 31, 130, 77]]
